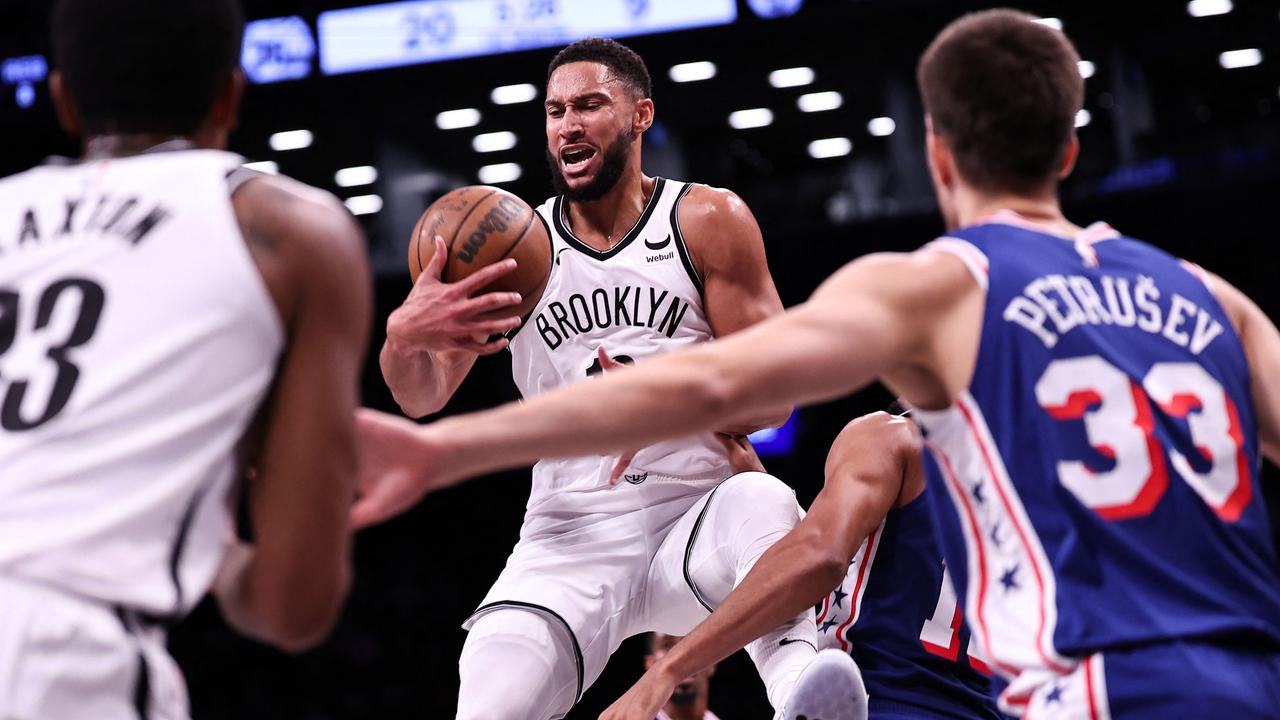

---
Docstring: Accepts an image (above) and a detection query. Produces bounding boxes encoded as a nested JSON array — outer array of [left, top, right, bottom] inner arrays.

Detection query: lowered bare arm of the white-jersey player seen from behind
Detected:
[[215, 177, 371, 651]]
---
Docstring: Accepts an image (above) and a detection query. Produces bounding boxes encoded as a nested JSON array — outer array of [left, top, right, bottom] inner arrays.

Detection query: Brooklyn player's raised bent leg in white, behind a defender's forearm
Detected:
[[648, 473, 817, 707]]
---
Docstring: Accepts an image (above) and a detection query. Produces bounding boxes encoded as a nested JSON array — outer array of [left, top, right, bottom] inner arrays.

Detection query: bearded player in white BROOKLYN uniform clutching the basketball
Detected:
[[381, 38, 860, 720]]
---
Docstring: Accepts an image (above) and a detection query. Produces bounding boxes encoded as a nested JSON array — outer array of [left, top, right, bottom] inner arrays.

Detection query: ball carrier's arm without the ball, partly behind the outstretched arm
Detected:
[[678, 184, 792, 434]]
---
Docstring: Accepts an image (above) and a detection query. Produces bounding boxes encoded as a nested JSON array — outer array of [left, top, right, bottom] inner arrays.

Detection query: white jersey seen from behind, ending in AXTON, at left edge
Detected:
[[0, 150, 284, 615]]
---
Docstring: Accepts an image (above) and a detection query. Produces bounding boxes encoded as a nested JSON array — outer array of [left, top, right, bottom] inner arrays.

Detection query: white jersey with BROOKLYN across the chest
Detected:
[[511, 178, 732, 509]]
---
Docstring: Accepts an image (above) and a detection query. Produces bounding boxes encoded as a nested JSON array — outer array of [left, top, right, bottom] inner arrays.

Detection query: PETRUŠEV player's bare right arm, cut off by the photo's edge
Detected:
[[1210, 274, 1280, 464]]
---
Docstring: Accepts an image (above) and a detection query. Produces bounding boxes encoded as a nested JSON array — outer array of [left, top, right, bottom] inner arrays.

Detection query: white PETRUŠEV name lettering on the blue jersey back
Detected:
[[1004, 274, 1222, 355]]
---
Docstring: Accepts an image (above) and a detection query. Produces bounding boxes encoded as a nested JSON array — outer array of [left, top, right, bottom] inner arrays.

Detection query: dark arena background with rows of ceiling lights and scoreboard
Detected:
[[0, 0, 1280, 720]]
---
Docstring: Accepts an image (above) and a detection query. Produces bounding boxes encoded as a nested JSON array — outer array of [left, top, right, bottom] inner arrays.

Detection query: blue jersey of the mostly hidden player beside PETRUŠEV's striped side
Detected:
[[817, 495, 1000, 720]]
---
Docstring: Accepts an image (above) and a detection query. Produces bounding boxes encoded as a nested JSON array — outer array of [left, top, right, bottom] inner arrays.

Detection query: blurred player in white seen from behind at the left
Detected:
[[0, 0, 370, 720]]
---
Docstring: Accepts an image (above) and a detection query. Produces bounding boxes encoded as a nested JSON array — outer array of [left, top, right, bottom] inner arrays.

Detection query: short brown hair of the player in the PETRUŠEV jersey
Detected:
[[916, 10, 1084, 192]]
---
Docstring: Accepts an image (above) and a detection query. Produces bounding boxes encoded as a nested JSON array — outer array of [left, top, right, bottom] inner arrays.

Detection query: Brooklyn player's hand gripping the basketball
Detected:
[[387, 236, 520, 355]]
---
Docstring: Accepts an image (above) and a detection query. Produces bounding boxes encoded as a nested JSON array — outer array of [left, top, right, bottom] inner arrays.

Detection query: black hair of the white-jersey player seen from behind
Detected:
[[52, 0, 244, 135]]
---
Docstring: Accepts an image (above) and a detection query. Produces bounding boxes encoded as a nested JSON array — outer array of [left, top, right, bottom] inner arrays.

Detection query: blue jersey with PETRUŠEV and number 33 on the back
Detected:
[[916, 213, 1280, 708]]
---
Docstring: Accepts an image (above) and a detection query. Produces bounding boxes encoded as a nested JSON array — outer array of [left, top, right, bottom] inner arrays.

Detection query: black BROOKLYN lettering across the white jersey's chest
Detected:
[[534, 286, 689, 350]]
